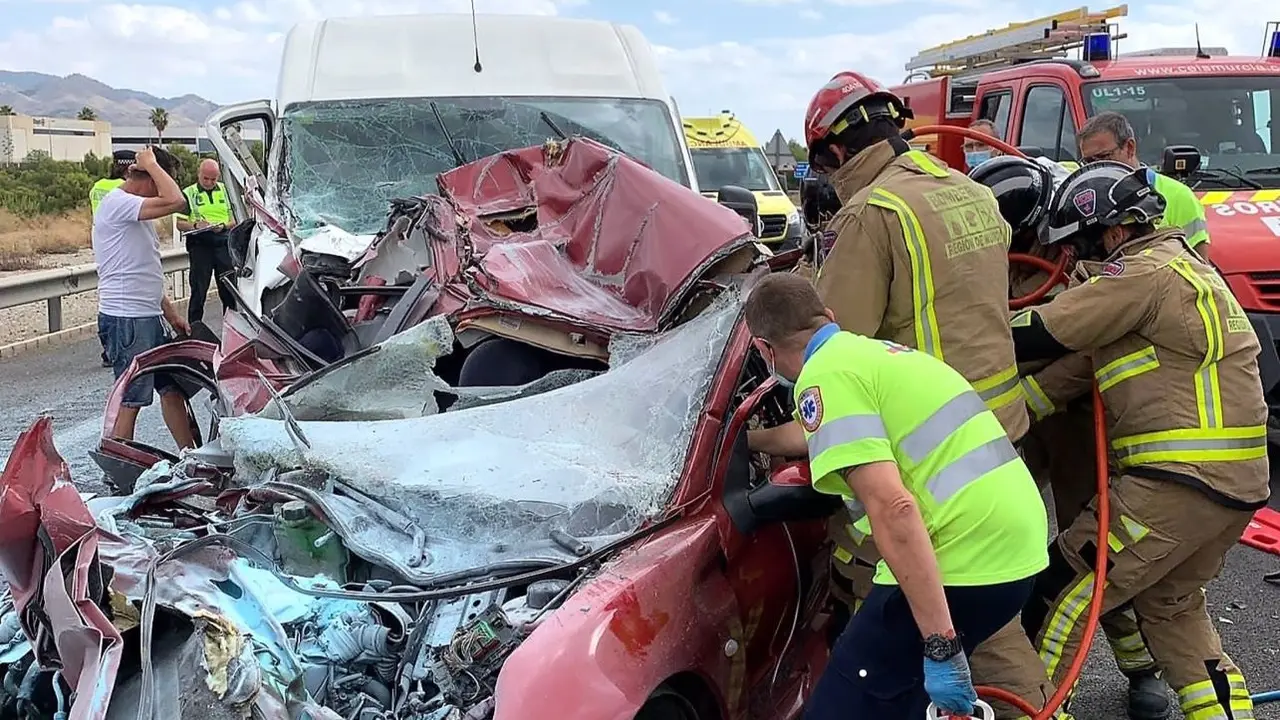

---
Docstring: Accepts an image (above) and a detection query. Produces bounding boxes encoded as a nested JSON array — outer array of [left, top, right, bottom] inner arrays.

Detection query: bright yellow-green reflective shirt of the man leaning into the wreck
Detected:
[[795, 324, 1048, 587]]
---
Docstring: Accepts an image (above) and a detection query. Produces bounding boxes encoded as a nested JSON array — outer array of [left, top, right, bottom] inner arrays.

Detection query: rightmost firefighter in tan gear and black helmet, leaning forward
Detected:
[[1012, 161, 1270, 720]]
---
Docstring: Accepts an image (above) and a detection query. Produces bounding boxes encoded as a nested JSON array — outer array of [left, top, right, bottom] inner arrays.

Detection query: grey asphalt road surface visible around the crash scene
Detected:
[[0, 316, 1280, 720]]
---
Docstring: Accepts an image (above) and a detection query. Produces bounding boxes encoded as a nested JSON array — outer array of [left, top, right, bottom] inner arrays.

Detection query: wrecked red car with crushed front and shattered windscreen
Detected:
[[0, 141, 838, 720]]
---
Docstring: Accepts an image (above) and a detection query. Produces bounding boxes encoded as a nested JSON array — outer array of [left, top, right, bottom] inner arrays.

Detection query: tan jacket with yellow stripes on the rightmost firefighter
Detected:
[[1012, 229, 1270, 510]]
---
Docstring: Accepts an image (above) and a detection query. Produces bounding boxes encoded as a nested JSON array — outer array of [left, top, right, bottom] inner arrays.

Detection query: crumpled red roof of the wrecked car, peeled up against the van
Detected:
[[404, 138, 751, 332]]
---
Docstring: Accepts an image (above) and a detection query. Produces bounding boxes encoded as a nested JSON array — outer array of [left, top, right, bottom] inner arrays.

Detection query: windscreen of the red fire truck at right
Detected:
[[1082, 76, 1280, 188]]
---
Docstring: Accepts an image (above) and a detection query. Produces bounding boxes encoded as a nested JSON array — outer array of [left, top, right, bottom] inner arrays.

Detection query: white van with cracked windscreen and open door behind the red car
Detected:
[[206, 14, 698, 313]]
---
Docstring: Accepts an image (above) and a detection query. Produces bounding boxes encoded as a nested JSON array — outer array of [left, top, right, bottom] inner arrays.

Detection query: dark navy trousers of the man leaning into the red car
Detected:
[[804, 578, 1036, 720]]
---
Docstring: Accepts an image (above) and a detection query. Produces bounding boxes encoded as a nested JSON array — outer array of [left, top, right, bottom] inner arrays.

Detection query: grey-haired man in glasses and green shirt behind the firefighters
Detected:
[[1075, 111, 1212, 261]]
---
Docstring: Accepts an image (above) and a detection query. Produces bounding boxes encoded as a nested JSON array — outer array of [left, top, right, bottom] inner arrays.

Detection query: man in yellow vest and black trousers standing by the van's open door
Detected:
[[178, 159, 234, 324]]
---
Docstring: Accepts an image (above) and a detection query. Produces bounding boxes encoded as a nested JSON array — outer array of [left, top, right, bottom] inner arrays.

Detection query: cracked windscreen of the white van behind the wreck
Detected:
[[279, 97, 689, 234]]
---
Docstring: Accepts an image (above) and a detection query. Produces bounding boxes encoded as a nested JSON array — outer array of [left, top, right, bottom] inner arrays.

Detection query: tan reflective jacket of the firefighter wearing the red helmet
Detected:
[[817, 134, 1030, 439]]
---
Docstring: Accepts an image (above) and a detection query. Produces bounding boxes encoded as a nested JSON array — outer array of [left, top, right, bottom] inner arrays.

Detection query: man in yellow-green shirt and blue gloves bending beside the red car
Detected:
[[745, 273, 1048, 720]]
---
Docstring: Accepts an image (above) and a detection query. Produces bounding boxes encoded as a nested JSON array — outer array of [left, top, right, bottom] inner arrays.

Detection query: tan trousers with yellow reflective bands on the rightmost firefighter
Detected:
[[1023, 475, 1253, 720]]
